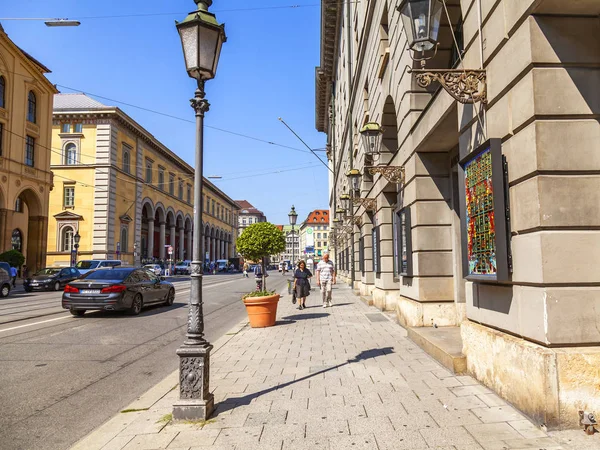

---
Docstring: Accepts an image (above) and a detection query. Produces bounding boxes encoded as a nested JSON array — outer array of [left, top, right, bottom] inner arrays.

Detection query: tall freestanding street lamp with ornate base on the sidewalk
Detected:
[[173, 0, 227, 420]]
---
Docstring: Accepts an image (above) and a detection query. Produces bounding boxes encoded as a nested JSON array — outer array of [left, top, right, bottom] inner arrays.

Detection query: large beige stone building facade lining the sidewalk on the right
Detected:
[[316, 0, 600, 428]]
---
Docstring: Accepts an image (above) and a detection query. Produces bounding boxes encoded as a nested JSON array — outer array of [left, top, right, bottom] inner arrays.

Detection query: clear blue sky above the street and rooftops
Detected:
[[0, 0, 328, 224]]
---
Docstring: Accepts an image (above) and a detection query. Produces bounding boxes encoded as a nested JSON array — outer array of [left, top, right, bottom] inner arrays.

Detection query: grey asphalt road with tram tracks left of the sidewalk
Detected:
[[0, 272, 288, 450]]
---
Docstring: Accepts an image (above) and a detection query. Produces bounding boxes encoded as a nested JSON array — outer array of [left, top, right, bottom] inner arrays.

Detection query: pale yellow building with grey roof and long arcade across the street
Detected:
[[48, 94, 237, 265]]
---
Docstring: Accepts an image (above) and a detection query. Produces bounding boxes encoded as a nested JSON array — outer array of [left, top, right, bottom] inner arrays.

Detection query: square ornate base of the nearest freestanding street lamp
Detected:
[[173, 343, 215, 420]]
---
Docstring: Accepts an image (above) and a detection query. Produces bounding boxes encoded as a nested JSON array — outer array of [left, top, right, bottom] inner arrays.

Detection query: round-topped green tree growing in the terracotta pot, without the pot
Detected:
[[236, 222, 285, 291]]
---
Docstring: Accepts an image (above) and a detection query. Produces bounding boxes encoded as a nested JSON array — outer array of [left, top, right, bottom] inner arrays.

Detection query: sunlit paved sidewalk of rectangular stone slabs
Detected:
[[74, 286, 600, 450]]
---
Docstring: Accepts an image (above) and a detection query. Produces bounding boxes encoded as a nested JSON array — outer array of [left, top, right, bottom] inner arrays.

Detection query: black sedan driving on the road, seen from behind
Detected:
[[62, 267, 175, 317]]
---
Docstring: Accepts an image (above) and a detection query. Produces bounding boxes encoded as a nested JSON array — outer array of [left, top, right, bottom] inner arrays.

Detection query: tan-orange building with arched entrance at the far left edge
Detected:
[[0, 25, 56, 270]]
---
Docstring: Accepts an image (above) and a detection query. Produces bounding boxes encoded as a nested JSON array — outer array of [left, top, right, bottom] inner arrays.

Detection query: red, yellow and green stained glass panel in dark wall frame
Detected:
[[464, 148, 497, 275]]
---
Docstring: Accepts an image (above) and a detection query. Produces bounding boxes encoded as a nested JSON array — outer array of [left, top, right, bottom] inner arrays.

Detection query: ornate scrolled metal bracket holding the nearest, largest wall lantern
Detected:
[[409, 69, 487, 104]]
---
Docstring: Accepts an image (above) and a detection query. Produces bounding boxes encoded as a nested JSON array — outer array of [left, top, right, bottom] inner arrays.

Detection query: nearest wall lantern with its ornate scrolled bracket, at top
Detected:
[[397, 0, 487, 103]]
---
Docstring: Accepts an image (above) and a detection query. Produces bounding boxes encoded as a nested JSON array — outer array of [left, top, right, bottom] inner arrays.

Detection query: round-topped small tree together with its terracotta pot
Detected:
[[236, 222, 285, 328]]
